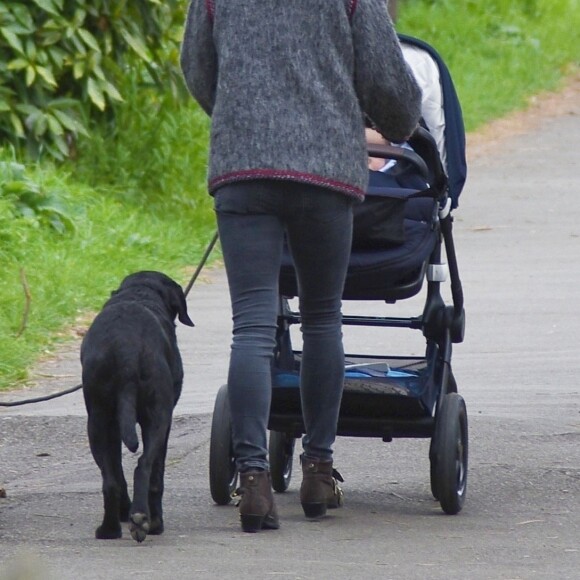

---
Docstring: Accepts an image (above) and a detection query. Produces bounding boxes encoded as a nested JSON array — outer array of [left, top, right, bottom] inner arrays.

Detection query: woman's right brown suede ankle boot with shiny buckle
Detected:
[[300, 455, 344, 519]]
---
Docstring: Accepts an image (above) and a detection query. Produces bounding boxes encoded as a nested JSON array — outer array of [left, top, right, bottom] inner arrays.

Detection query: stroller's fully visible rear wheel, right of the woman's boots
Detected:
[[430, 393, 468, 515]]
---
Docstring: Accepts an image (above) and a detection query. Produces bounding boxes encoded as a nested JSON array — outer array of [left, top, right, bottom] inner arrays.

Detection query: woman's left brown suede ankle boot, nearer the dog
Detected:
[[238, 471, 280, 532]]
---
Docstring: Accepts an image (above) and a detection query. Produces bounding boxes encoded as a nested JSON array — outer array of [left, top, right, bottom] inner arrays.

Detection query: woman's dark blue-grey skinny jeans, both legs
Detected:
[[214, 180, 353, 471]]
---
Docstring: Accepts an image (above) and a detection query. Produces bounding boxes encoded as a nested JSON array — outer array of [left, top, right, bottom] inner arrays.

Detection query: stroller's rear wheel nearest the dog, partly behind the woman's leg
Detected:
[[209, 385, 238, 505]]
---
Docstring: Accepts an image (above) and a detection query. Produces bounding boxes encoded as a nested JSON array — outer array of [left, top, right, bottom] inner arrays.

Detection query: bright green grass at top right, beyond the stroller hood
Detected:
[[397, 0, 580, 131]]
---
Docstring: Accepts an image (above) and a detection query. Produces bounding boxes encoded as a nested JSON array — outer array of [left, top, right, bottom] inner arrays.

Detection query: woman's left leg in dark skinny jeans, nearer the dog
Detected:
[[215, 182, 284, 471]]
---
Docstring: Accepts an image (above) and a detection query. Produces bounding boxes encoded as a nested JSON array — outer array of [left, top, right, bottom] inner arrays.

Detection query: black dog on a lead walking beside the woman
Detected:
[[81, 272, 193, 542]]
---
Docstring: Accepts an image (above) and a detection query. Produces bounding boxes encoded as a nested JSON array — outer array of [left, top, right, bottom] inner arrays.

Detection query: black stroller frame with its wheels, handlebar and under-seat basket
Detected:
[[209, 37, 468, 514]]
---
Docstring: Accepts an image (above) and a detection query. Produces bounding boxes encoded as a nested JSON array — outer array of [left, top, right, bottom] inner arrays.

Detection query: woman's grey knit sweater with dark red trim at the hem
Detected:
[[181, 0, 421, 199]]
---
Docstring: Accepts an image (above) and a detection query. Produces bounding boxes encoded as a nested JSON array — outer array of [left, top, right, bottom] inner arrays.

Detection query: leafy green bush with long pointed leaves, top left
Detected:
[[0, 0, 184, 159]]
